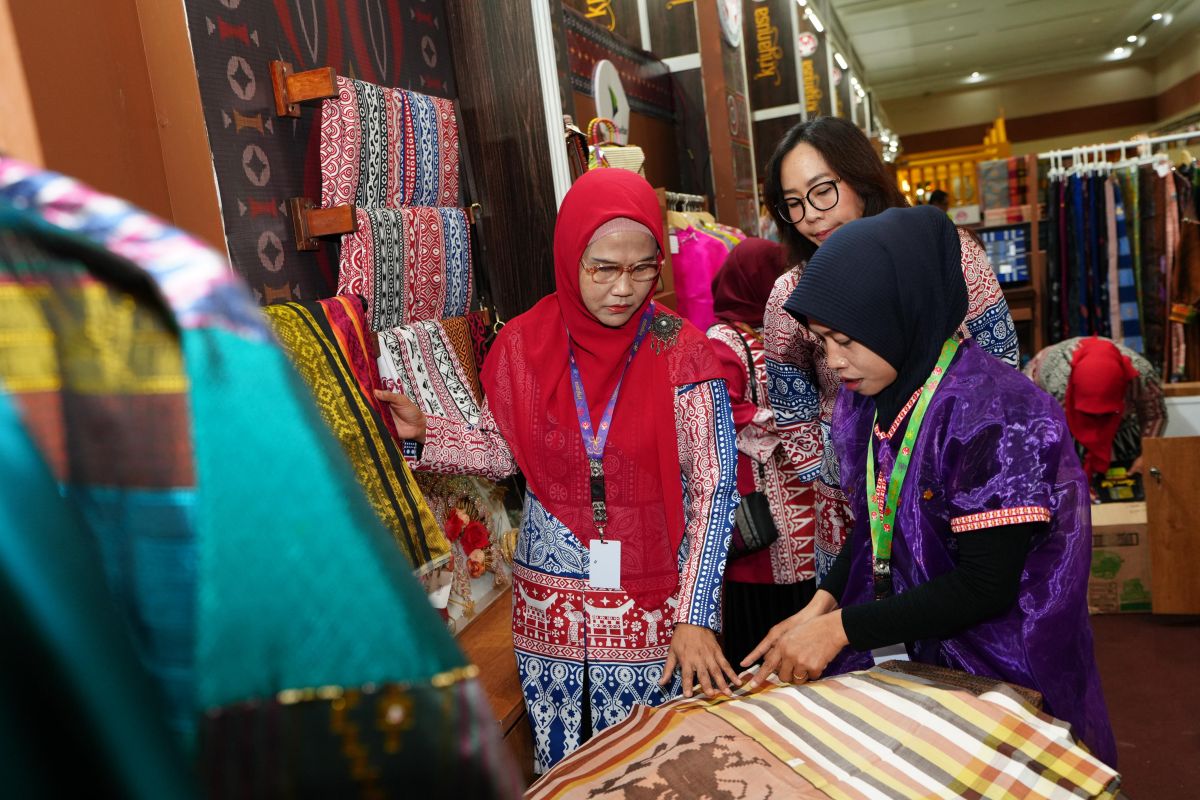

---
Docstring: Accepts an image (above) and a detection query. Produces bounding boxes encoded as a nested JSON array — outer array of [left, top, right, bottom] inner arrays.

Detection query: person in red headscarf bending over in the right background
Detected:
[[1025, 336, 1166, 476]]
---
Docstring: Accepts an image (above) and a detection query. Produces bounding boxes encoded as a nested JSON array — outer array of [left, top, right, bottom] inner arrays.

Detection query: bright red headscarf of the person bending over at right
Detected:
[[1063, 336, 1138, 475]]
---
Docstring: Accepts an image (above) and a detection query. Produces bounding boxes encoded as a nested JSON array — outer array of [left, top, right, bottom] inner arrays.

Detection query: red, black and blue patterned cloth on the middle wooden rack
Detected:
[[337, 207, 472, 331]]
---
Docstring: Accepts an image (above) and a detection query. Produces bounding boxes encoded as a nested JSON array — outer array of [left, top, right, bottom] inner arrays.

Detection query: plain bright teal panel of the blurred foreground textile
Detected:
[[184, 330, 466, 711]]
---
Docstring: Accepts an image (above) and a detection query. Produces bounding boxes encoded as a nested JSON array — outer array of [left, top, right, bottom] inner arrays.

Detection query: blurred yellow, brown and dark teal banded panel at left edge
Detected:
[[0, 224, 196, 735]]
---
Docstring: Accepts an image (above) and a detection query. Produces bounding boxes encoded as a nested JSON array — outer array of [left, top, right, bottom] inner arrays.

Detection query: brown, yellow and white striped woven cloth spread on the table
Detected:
[[526, 669, 1120, 800]]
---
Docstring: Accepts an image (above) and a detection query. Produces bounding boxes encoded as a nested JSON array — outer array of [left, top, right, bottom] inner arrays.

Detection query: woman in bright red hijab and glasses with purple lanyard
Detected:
[[380, 169, 738, 772]]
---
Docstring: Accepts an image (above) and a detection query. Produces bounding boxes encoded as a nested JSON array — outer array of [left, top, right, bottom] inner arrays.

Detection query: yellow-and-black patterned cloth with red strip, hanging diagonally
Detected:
[[266, 296, 450, 573]]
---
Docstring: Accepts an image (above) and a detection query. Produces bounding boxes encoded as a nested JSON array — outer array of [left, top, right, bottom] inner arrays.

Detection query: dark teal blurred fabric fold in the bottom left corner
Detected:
[[0, 392, 196, 799]]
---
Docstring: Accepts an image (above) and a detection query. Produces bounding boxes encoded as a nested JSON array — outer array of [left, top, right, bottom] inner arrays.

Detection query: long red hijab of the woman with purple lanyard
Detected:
[[482, 169, 720, 609]]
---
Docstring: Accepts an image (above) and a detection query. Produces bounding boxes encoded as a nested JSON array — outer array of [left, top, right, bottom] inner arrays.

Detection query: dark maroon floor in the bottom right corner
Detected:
[[1092, 614, 1200, 800]]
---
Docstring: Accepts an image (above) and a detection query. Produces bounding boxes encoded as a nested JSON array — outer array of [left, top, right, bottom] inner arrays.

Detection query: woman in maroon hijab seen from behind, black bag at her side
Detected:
[[708, 239, 816, 663]]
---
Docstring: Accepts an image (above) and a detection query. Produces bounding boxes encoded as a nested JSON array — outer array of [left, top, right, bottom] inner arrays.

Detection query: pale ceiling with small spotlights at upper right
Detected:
[[828, 0, 1200, 100]]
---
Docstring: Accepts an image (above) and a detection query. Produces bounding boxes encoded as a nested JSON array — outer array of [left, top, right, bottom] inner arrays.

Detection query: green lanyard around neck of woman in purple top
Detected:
[[866, 337, 959, 600]]
